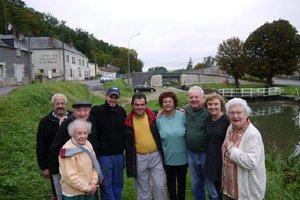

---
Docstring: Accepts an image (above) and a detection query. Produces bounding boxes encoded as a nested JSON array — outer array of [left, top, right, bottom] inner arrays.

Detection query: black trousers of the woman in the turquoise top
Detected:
[[164, 164, 188, 200]]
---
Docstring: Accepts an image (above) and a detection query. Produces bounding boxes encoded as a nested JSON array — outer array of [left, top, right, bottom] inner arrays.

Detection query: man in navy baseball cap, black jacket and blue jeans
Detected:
[[91, 87, 126, 200]]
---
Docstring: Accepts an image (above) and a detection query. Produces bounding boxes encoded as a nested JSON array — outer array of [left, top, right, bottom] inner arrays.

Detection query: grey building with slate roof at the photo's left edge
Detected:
[[0, 35, 31, 86]]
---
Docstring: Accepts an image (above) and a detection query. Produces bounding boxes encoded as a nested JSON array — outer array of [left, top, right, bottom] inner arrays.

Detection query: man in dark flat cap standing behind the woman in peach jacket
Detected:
[[50, 101, 98, 200]]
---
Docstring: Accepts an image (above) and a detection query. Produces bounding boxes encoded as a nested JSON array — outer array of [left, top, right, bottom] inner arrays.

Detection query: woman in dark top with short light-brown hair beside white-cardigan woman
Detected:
[[204, 93, 230, 200]]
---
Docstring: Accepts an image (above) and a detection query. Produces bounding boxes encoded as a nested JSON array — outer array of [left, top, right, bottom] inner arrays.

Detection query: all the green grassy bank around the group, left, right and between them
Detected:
[[0, 81, 300, 200]]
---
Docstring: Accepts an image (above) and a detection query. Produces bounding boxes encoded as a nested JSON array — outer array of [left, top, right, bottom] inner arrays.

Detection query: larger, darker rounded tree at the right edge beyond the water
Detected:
[[244, 19, 300, 87]]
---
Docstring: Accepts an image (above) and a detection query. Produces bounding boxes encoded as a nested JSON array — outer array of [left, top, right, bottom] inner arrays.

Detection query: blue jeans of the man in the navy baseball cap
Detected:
[[99, 154, 124, 200]]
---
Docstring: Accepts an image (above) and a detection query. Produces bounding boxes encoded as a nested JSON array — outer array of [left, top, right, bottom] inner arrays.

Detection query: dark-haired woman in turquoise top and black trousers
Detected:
[[156, 92, 187, 200]]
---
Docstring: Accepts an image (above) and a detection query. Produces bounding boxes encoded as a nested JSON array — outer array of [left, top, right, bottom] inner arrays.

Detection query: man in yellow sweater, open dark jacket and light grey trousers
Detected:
[[125, 93, 167, 200]]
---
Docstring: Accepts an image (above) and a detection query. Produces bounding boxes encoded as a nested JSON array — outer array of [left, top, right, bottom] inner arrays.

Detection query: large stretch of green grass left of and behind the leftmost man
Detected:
[[0, 82, 103, 200]]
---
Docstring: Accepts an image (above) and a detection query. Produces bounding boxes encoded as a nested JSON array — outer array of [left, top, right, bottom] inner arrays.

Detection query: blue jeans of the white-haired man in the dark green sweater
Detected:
[[187, 150, 206, 200]]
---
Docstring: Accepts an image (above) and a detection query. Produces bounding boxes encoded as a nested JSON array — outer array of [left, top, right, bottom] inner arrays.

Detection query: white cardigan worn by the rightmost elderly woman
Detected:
[[226, 123, 266, 200]]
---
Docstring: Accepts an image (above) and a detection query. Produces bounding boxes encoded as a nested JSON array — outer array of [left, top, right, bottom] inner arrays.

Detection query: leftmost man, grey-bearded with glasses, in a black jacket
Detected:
[[36, 93, 71, 199]]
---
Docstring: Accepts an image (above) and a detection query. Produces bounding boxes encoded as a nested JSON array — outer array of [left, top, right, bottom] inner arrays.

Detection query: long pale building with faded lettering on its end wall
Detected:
[[26, 37, 90, 81]]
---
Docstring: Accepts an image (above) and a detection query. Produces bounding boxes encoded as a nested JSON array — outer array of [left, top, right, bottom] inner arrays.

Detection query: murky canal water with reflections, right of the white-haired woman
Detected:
[[249, 101, 300, 155]]
